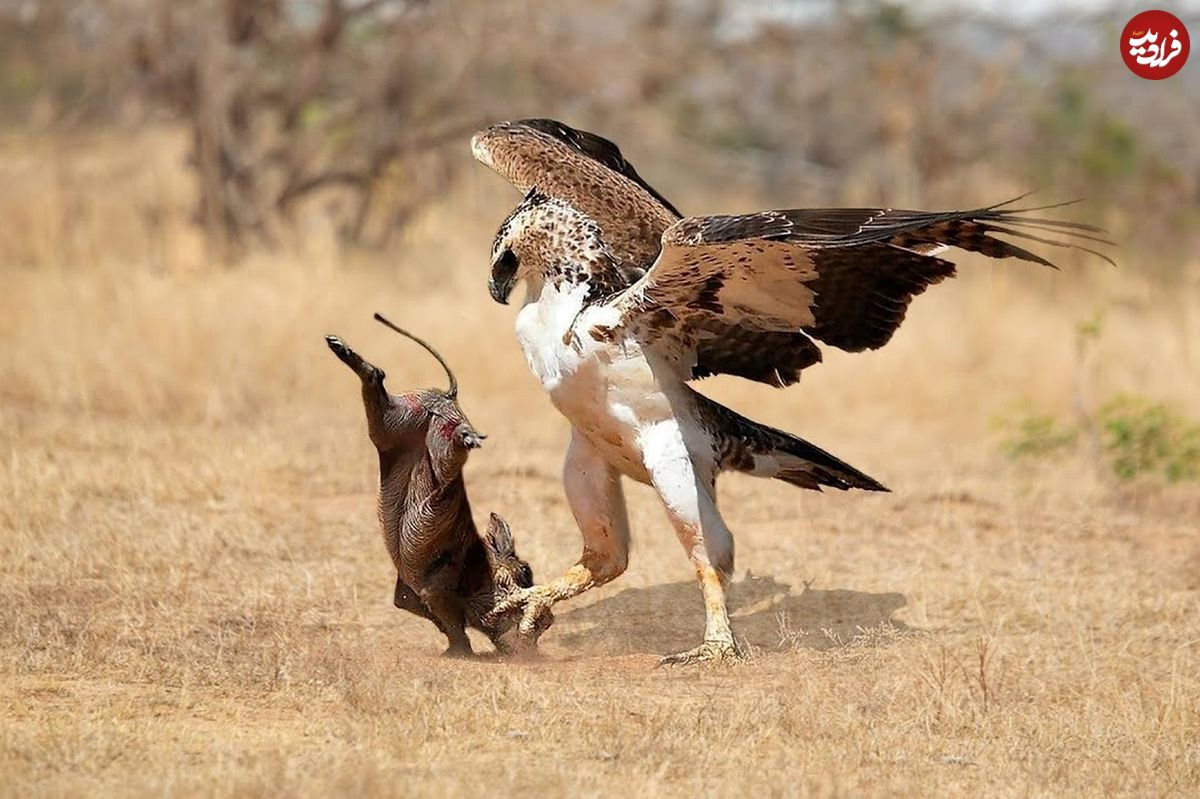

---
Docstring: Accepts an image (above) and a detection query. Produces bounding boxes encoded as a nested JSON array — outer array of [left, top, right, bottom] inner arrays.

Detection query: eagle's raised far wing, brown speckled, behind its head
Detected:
[[470, 119, 680, 269]]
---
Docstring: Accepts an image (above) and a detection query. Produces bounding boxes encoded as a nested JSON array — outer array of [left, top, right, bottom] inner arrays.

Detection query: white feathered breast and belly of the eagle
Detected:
[[516, 281, 698, 482]]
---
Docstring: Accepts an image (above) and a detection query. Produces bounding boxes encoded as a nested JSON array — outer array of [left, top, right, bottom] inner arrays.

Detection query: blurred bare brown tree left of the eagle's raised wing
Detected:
[[134, 0, 484, 260]]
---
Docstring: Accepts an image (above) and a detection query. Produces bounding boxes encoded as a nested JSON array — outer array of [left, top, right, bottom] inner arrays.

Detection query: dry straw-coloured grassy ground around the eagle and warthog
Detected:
[[7, 127, 1200, 795]]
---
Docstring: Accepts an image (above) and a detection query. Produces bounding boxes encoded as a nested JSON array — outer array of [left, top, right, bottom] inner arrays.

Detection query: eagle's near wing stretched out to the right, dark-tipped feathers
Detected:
[[613, 199, 1110, 385]]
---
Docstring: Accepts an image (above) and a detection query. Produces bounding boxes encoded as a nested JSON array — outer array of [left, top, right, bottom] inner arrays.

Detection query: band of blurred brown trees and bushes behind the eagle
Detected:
[[0, 0, 1200, 267]]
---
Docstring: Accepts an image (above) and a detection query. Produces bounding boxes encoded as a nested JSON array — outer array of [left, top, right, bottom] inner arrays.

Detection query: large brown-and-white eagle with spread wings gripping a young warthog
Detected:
[[472, 119, 1103, 663]]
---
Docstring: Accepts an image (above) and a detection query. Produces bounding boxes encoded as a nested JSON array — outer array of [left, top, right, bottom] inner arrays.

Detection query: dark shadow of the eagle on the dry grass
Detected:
[[553, 573, 913, 655]]
